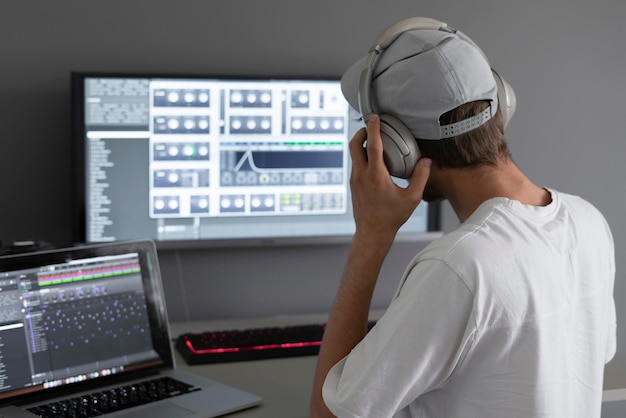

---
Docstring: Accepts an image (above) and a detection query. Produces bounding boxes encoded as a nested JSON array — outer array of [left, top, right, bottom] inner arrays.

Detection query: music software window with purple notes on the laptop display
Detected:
[[0, 254, 157, 397]]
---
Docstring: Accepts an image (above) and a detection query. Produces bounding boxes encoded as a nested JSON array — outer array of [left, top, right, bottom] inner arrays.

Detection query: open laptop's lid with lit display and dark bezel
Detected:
[[0, 241, 171, 399]]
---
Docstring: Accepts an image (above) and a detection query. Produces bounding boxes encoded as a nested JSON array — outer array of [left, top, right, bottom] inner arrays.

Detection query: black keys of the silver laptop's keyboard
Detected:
[[28, 377, 200, 418]]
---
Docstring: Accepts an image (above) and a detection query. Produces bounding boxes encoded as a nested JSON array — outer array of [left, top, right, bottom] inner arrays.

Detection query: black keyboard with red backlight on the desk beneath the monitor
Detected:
[[176, 321, 374, 364]]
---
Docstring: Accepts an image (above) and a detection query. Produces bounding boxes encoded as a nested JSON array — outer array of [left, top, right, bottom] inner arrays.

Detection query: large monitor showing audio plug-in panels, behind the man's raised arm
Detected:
[[72, 73, 437, 248]]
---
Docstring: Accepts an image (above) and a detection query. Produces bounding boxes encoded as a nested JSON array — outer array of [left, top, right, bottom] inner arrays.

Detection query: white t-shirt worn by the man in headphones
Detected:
[[323, 190, 616, 418]]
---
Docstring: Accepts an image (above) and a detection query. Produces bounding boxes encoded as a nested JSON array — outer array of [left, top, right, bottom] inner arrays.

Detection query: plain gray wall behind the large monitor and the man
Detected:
[[0, 0, 626, 362]]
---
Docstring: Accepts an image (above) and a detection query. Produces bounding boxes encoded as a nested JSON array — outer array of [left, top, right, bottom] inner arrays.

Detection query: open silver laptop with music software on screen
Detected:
[[0, 240, 261, 418]]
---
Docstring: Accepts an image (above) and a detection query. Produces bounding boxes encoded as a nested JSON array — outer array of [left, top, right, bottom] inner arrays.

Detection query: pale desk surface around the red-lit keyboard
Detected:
[[171, 313, 626, 418]]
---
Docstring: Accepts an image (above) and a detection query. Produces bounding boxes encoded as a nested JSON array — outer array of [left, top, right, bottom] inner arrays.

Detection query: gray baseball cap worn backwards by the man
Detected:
[[341, 29, 498, 140]]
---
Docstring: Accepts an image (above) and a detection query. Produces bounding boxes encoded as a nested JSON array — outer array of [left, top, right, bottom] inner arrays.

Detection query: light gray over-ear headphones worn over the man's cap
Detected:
[[358, 17, 516, 179]]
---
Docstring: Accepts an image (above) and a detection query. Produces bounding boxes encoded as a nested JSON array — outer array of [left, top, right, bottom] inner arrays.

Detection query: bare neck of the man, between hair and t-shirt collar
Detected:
[[440, 158, 551, 222]]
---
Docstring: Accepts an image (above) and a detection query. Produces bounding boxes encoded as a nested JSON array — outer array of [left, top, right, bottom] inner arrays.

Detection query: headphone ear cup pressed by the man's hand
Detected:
[[380, 114, 421, 179]]
